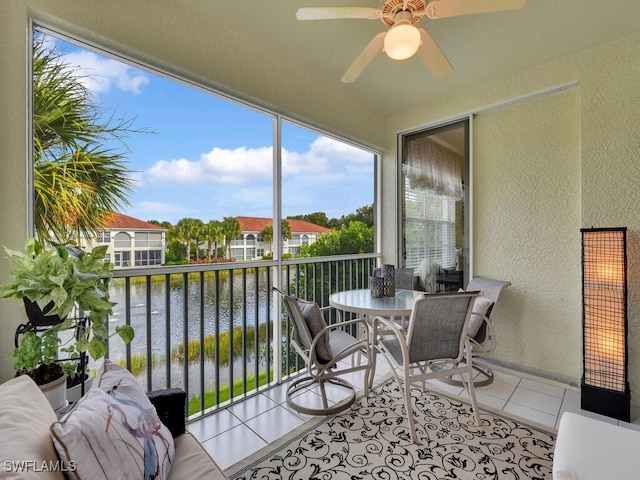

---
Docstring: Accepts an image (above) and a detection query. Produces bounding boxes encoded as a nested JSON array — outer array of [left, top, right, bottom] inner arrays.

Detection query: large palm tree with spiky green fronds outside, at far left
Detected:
[[33, 35, 144, 242]]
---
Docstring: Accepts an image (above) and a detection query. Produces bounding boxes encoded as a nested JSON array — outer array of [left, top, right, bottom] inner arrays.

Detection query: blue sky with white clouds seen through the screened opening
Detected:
[[57, 33, 374, 223]]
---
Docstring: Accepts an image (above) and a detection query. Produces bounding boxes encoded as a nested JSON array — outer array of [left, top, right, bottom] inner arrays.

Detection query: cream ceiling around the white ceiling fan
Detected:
[[180, 0, 640, 114]]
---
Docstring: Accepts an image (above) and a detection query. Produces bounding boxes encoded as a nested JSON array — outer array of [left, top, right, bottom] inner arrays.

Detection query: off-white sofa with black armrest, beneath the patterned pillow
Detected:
[[0, 376, 226, 480]]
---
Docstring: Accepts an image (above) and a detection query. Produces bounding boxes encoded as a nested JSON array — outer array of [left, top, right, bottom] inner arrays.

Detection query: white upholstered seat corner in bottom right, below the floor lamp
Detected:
[[553, 412, 640, 480]]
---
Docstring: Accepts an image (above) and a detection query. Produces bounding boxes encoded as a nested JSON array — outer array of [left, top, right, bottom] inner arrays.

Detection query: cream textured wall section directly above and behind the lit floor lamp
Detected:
[[580, 36, 640, 405]]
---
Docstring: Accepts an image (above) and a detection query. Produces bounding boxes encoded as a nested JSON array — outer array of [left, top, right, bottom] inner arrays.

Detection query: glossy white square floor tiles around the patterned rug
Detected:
[[188, 357, 640, 469]]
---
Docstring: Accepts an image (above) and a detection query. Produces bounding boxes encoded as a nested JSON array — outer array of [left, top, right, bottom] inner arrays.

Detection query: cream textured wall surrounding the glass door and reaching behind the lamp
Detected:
[[382, 31, 640, 405]]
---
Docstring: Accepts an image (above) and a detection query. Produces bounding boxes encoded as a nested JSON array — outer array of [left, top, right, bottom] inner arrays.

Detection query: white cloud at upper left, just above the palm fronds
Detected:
[[64, 50, 149, 94]]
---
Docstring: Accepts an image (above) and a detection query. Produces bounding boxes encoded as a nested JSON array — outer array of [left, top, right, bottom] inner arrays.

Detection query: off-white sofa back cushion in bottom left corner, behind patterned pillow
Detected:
[[0, 375, 64, 480]]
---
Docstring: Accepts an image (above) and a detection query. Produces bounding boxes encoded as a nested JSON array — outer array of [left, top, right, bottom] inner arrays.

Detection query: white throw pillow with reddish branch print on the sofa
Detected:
[[50, 360, 175, 480]]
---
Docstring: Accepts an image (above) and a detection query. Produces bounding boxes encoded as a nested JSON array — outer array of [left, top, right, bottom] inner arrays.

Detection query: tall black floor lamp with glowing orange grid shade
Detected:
[[580, 227, 631, 421]]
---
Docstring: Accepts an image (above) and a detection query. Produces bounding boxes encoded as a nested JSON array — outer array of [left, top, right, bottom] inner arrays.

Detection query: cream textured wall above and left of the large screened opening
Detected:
[[0, 0, 386, 382]]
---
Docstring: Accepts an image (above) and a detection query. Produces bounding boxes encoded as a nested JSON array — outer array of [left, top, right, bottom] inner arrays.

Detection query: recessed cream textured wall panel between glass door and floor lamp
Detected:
[[473, 88, 581, 378]]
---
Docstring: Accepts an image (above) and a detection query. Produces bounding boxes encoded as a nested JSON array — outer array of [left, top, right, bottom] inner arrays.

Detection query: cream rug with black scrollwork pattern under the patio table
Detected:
[[225, 379, 556, 480]]
